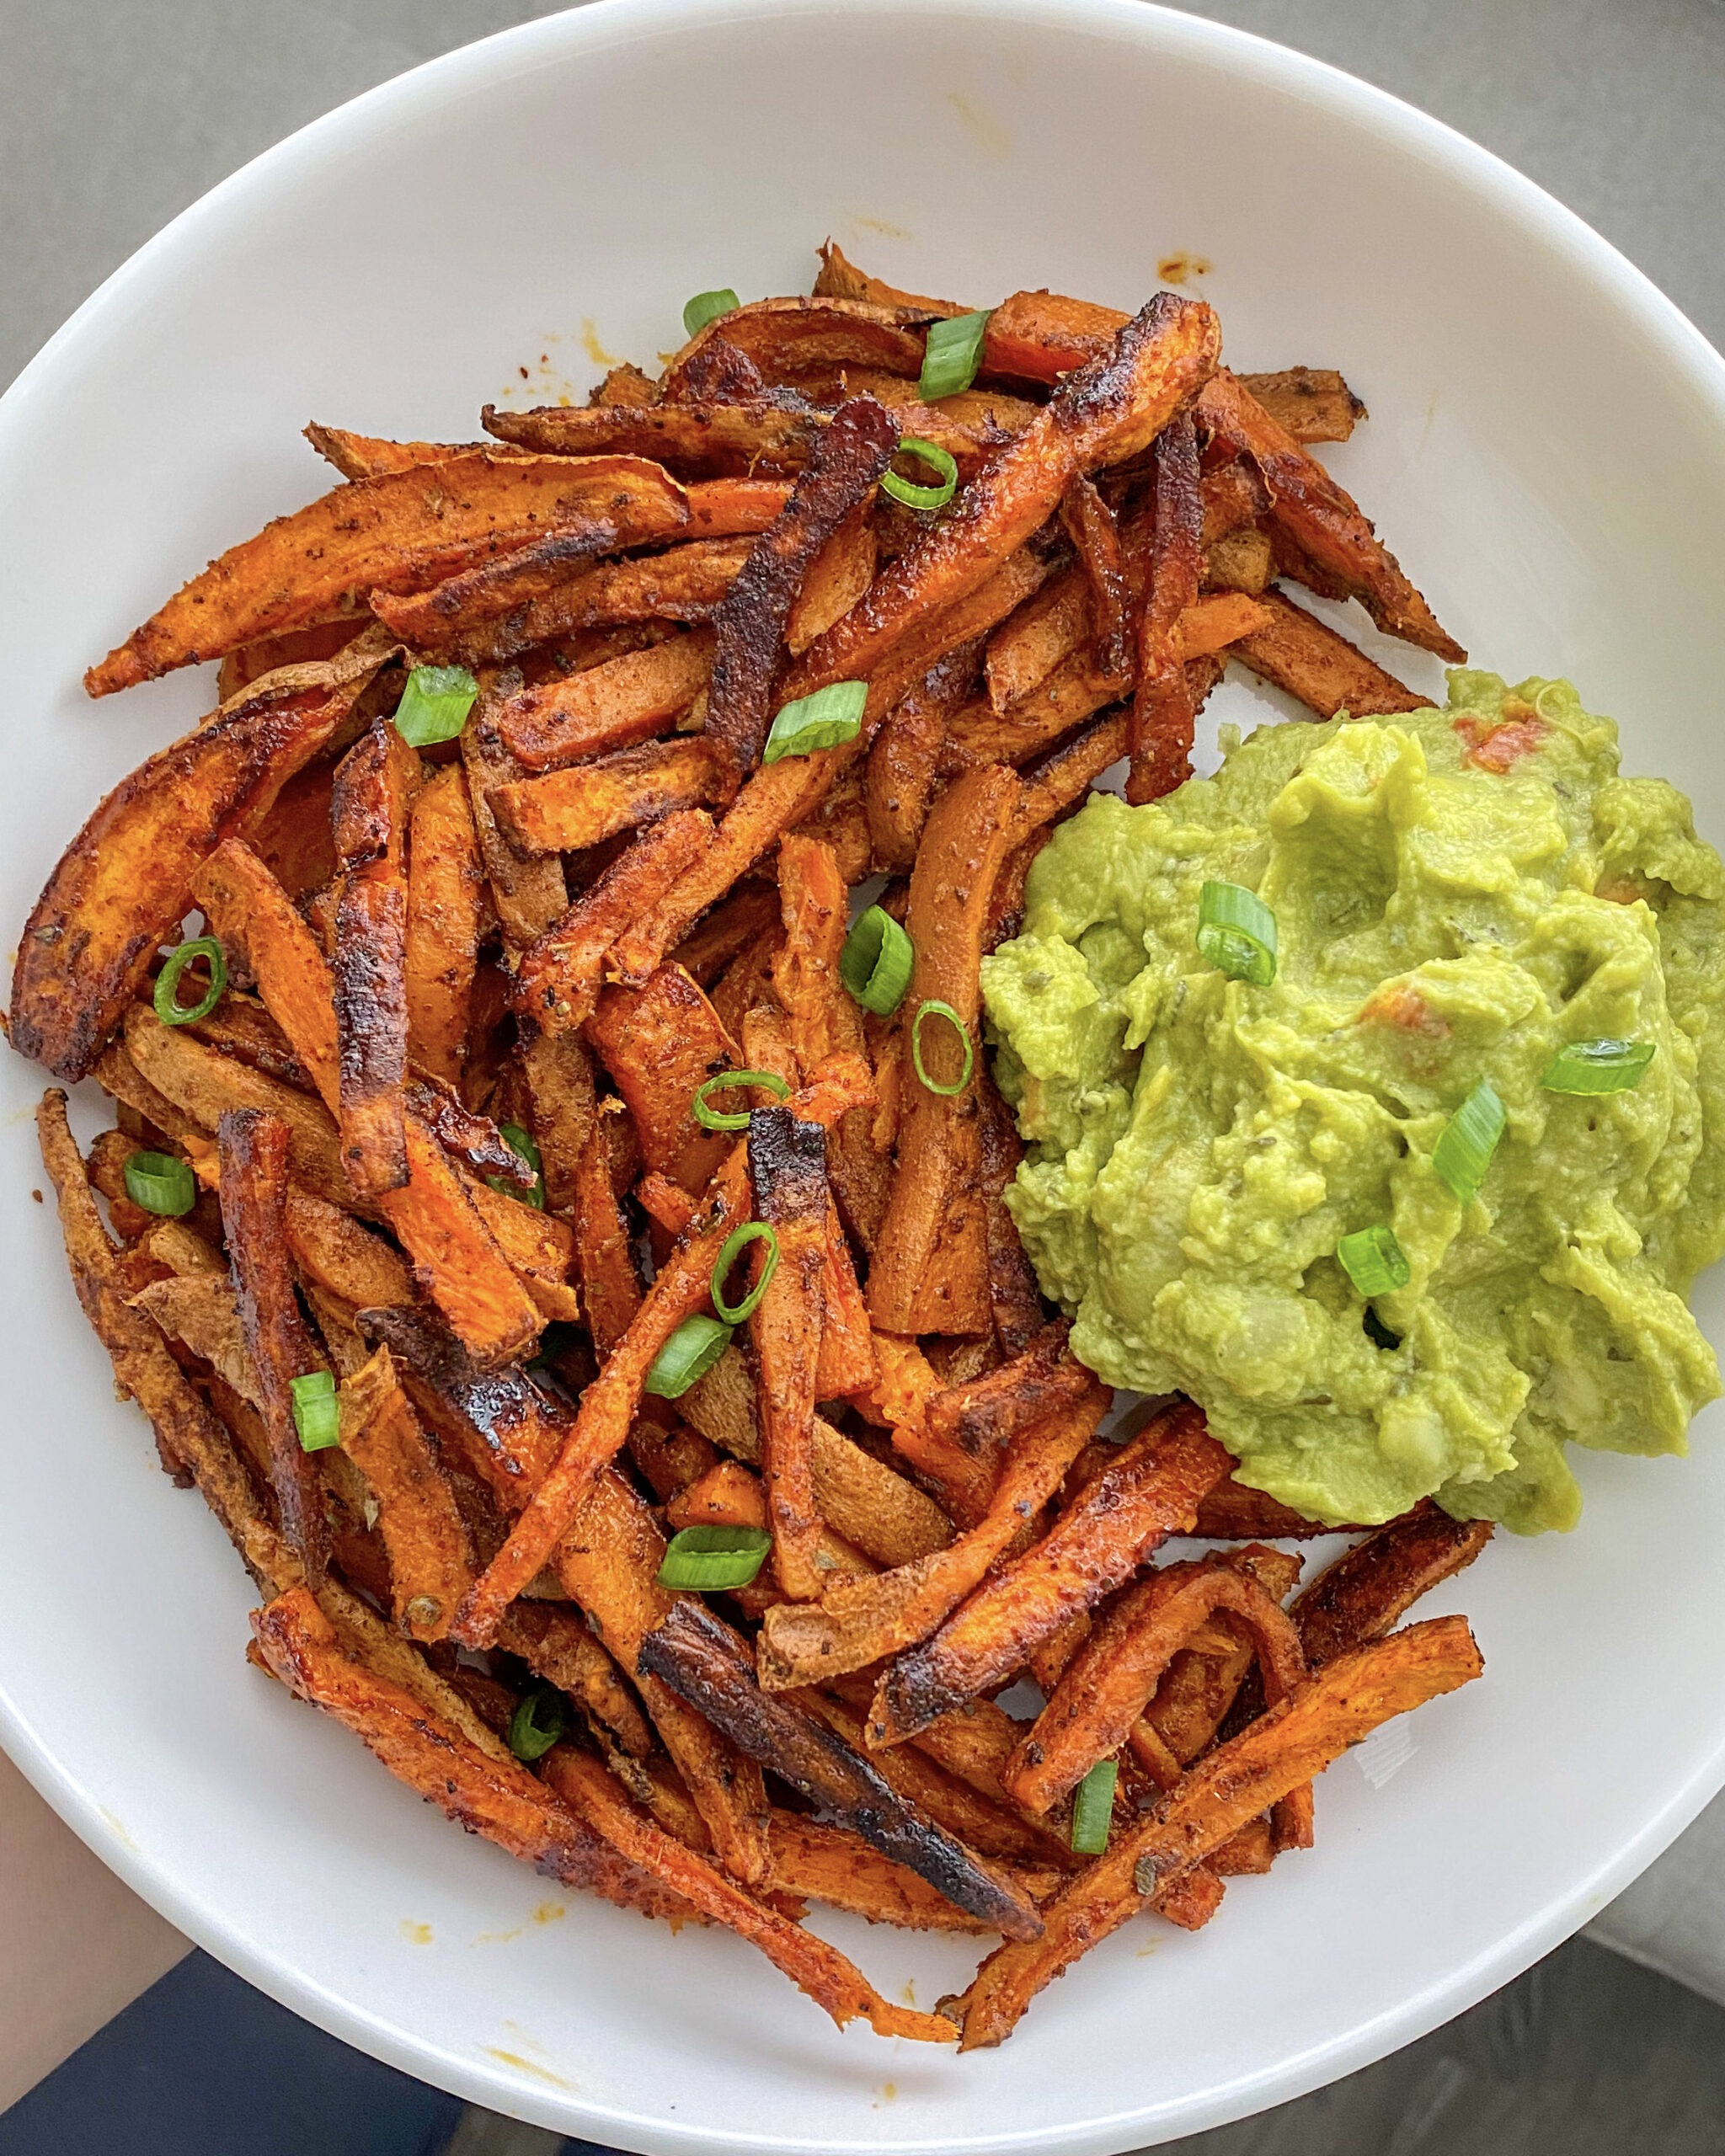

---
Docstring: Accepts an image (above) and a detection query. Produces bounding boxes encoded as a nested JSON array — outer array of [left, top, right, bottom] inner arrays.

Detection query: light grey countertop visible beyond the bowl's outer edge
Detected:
[[0, 0, 1725, 2069]]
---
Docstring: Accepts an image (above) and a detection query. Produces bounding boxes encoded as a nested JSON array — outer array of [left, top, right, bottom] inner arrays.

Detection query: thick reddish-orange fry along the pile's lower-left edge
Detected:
[[253, 1587, 694, 1919]]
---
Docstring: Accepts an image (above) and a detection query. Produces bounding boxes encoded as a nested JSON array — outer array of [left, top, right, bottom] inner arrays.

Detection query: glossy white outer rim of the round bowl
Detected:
[[0, 0, 1725, 2156]]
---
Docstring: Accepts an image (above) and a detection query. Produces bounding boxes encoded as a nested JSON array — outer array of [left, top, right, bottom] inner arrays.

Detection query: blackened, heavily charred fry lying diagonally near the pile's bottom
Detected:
[[640, 1595, 1041, 1938]]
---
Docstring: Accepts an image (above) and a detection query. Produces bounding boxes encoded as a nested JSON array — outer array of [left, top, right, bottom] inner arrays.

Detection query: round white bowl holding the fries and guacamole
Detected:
[[0, 0, 1725, 2152]]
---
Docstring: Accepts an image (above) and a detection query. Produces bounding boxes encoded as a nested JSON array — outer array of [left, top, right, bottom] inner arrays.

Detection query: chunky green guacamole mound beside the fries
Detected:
[[983, 670, 1725, 1533]]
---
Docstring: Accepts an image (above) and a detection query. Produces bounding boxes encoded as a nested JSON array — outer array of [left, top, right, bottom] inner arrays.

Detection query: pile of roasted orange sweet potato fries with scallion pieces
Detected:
[[8, 248, 1490, 2048]]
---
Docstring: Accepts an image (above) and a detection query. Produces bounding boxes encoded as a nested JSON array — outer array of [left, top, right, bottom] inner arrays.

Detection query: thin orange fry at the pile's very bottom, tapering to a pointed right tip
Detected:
[[546, 1744, 953, 2044]]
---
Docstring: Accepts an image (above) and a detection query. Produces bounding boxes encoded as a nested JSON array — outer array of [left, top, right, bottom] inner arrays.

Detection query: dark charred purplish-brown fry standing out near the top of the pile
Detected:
[[708, 397, 900, 793]]
